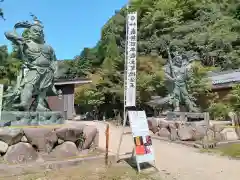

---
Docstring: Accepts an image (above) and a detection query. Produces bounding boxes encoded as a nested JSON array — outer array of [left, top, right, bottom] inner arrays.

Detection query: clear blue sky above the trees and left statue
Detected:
[[0, 0, 127, 60]]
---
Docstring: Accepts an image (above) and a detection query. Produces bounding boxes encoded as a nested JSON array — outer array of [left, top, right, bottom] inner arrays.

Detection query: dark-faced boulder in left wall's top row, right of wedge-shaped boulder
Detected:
[[56, 125, 85, 142]]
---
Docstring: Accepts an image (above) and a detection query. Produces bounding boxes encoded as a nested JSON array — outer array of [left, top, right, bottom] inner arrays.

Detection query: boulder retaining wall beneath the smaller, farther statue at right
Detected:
[[148, 118, 227, 141]]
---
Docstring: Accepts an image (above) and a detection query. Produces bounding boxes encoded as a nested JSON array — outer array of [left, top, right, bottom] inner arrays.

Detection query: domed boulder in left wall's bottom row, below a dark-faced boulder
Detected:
[[50, 141, 79, 159]]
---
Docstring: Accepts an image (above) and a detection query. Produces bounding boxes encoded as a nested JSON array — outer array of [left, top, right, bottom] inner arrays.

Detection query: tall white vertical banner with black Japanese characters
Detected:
[[125, 12, 137, 107]]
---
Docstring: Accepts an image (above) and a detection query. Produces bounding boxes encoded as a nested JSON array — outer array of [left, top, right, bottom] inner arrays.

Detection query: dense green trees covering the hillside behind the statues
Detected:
[[0, 0, 240, 120]]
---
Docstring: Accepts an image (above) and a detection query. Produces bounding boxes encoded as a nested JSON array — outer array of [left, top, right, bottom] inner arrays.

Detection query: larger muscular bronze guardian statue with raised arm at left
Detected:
[[5, 18, 61, 111]]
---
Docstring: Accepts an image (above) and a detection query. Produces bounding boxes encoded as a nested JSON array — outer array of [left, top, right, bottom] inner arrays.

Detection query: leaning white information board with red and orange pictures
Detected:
[[128, 111, 155, 164]]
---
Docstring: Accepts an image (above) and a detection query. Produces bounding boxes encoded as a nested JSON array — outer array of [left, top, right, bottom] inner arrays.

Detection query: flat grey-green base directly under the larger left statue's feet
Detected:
[[0, 111, 65, 127]]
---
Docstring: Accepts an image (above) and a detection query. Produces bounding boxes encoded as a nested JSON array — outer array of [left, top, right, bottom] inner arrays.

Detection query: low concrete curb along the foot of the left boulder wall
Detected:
[[0, 153, 116, 178]]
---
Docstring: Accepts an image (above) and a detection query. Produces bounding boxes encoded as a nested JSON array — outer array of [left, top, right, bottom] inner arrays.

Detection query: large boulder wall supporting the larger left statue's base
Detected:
[[0, 124, 99, 163]]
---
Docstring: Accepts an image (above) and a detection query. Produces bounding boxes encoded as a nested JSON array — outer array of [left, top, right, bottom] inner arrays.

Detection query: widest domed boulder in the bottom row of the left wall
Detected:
[[4, 142, 38, 163]]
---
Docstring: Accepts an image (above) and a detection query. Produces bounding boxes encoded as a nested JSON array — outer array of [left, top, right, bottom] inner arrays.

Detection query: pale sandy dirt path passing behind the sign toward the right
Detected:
[[66, 122, 240, 180]]
